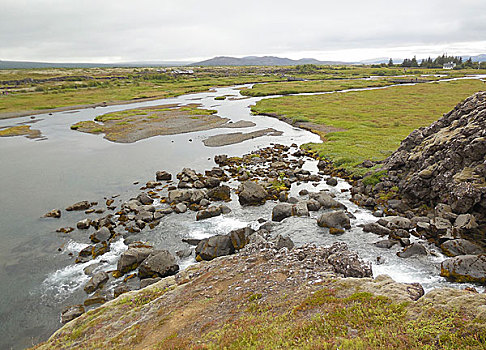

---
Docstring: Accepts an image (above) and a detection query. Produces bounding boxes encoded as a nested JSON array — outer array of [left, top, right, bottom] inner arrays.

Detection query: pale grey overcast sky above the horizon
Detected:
[[0, 0, 486, 62]]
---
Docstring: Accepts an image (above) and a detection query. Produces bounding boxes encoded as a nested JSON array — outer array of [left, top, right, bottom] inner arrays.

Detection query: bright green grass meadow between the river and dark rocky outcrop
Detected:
[[252, 80, 486, 172]]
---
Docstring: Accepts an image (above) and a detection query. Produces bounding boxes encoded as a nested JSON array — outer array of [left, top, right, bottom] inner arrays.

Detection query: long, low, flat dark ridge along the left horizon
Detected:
[[0, 60, 194, 69]]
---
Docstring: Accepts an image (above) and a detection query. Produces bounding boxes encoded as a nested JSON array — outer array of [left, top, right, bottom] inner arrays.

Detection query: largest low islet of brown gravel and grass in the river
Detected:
[[71, 104, 232, 143]]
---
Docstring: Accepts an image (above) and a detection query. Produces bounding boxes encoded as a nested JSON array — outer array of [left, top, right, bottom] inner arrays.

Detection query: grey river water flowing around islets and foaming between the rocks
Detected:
[[0, 82, 482, 349]]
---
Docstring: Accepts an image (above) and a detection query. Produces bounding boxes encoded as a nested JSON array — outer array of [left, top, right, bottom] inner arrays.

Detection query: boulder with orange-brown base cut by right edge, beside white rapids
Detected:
[[440, 254, 486, 284]]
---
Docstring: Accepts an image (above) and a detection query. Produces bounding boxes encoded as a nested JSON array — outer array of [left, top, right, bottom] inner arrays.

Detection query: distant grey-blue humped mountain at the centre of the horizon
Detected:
[[190, 56, 350, 66]]
